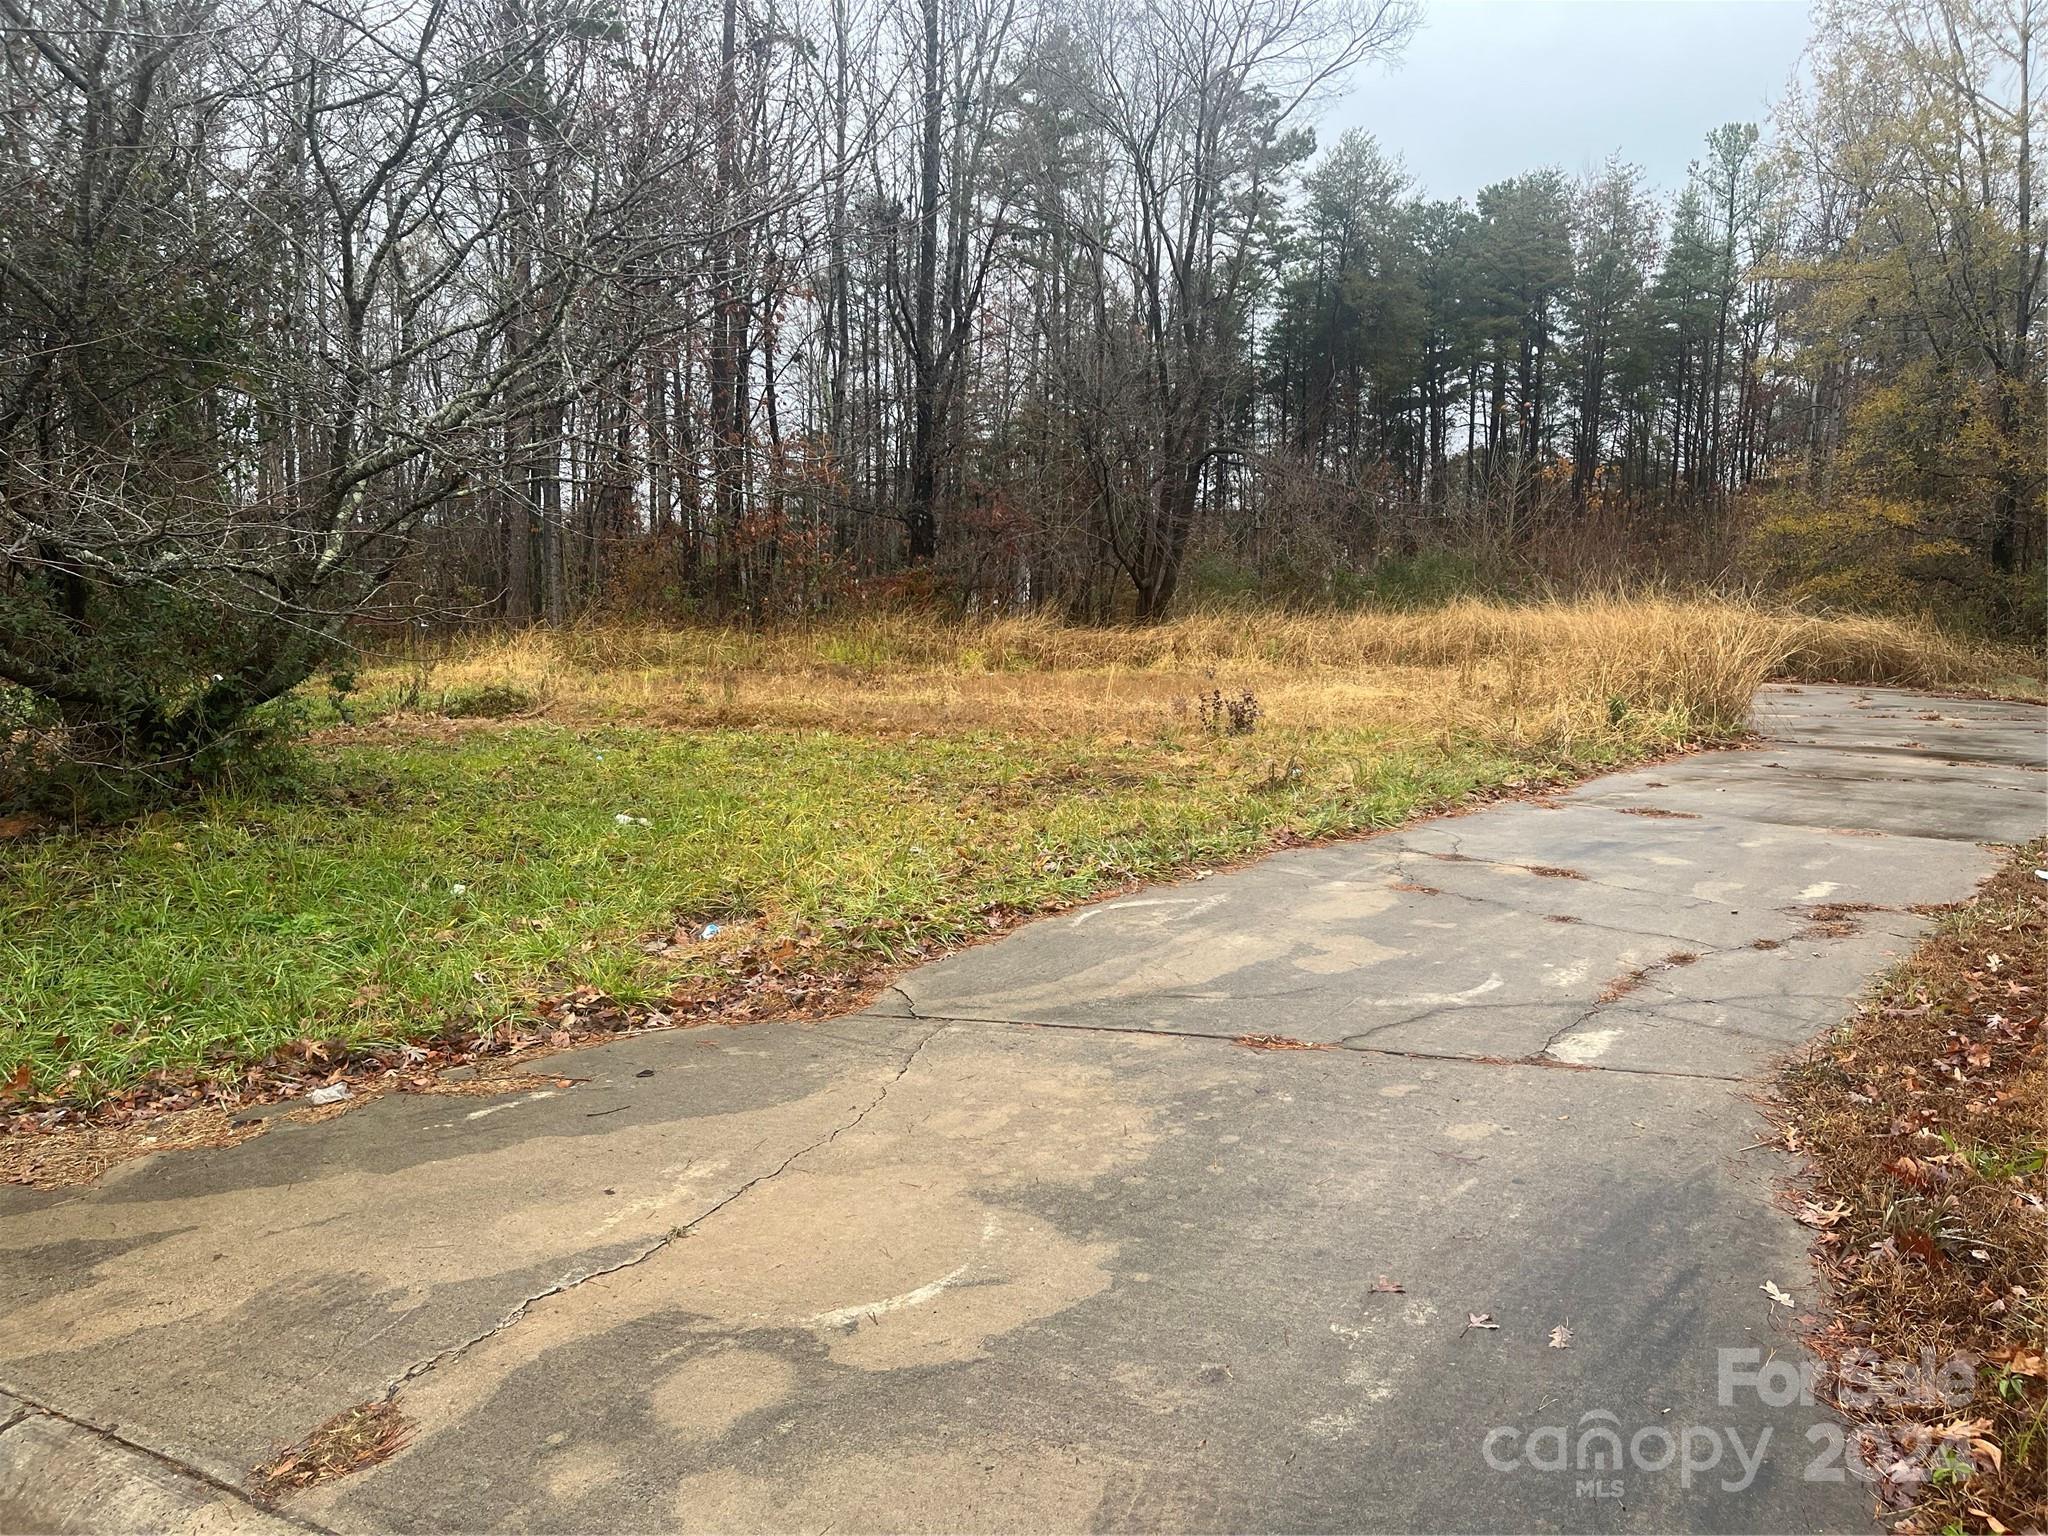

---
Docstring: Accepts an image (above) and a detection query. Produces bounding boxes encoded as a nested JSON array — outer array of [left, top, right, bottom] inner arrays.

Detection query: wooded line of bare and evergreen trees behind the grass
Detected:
[[0, 0, 2048, 754]]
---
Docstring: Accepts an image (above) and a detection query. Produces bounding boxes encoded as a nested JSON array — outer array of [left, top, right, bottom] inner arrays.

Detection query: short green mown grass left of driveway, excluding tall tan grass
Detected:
[[0, 725, 1671, 1100]]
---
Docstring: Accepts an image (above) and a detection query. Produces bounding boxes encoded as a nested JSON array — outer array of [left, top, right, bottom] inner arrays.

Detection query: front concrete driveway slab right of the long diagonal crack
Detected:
[[299, 1024, 1862, 1530]]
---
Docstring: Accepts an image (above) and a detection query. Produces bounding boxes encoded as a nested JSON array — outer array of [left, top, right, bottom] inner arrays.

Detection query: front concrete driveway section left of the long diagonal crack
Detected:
[[0, 1028, 922, 1481]]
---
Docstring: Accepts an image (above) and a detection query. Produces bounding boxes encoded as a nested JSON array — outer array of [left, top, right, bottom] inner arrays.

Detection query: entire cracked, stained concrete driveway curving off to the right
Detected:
[[0, 688, 2048, 1532]]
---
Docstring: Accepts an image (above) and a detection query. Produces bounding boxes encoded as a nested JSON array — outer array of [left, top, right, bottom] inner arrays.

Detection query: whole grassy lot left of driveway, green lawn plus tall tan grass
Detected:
[[0, 598, 2013, 1128]]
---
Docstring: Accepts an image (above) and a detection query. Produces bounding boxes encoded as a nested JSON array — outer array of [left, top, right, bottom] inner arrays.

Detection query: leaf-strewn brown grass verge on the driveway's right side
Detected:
[[1782, 842, 2048, 1532]]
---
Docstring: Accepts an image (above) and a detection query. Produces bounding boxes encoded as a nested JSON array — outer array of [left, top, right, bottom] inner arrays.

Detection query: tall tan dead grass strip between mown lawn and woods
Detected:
[[367, 596, 2023, 752]]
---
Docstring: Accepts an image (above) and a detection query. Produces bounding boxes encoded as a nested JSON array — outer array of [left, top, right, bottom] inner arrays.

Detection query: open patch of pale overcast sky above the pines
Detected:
[[1317, 0, 1808, 199]]
